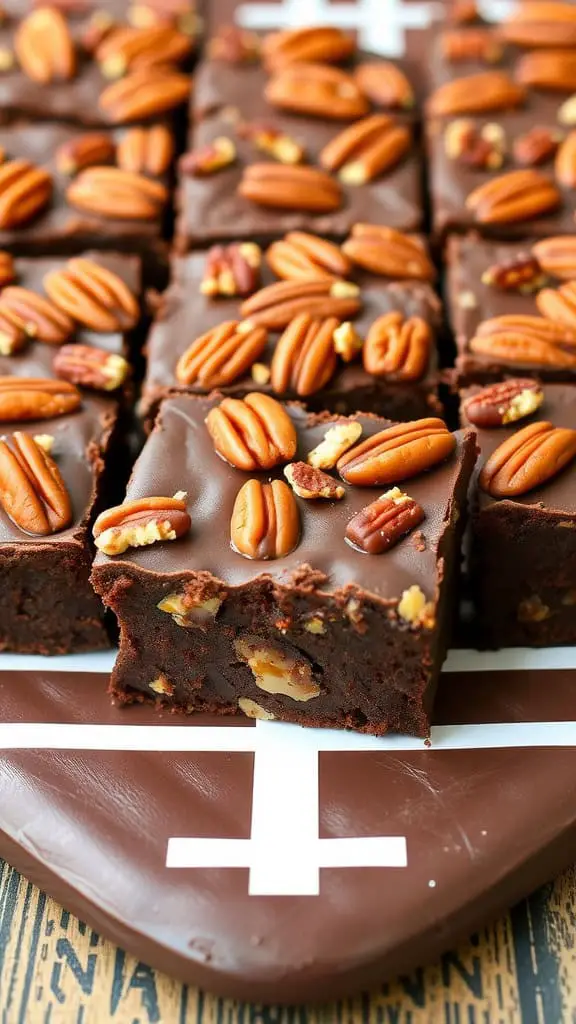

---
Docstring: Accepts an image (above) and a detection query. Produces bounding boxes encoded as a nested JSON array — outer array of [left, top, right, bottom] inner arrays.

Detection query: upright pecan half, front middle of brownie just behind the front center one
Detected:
[[271, 313, 338, 397]]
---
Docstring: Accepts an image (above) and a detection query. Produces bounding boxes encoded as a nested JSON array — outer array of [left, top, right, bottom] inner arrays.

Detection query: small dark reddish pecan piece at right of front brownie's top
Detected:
[[345, 487, 424, 555]]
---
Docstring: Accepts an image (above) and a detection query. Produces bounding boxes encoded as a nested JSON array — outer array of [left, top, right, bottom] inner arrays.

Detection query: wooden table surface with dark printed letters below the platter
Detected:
[[0, 861, 576, 1024]]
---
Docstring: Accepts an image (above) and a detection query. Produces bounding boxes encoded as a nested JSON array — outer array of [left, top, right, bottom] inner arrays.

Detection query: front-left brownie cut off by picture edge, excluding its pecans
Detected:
[[0, 394, 116, 654]]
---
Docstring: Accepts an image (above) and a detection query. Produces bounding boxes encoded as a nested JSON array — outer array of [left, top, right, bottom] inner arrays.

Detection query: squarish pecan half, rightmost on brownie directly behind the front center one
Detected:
[[362, 310, 433, 381]]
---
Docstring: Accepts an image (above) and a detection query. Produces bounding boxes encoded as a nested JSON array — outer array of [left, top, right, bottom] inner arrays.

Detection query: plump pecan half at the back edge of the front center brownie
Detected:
[[206, 392, 297, 472]]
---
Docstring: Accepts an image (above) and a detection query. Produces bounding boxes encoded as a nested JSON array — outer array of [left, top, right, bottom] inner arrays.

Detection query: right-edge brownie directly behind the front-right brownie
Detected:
[[446, 234, 576, 385]]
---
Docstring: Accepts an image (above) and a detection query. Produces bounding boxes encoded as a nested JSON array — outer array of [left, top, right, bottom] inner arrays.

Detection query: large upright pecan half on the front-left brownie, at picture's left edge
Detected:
[[0, 431, 72, 537]]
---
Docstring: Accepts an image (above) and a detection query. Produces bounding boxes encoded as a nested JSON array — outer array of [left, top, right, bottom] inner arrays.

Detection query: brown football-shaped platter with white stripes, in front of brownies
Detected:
[[0, 648, 576, 1002]]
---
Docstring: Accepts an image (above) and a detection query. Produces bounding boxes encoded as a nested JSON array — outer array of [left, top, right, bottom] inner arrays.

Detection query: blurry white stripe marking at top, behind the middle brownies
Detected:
[[236, 0, 443, 57]]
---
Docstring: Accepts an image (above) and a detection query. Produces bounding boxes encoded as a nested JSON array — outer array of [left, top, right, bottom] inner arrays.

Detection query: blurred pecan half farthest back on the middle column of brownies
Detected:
[[261, 25, 356, 71]]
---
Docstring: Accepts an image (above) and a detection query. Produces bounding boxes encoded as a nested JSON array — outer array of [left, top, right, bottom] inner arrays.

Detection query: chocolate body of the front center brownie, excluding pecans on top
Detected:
[[92, 396, 476, 735]]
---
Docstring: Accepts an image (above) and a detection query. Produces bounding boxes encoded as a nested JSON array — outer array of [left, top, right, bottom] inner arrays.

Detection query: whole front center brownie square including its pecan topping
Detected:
[[92, 394, 476, 735]]
